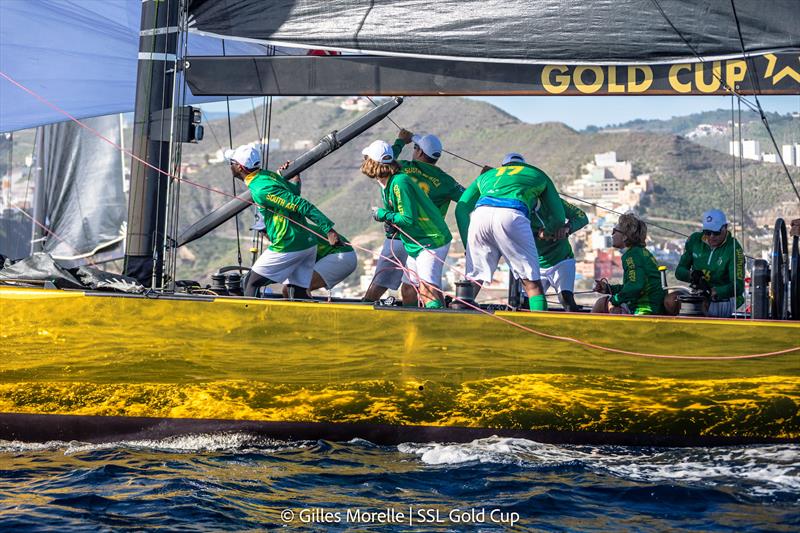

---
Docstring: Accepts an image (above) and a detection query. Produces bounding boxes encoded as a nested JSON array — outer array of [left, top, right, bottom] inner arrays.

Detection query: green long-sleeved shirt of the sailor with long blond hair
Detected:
[[378, 172, 453, 257]]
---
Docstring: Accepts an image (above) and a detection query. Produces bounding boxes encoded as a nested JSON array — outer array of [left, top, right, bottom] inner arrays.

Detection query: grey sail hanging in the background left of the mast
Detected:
[[33, 115, 128, 266]]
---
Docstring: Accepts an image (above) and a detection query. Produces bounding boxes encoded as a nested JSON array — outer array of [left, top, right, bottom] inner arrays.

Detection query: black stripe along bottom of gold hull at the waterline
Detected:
[[0, 413, 800, 446]]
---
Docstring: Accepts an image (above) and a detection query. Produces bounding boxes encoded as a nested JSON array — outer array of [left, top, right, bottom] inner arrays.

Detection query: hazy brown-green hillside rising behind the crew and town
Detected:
[[4, 97, 792, 278]]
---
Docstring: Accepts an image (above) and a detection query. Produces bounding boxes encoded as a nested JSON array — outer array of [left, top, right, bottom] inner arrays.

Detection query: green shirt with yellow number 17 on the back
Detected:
[[456, 163, 566, 247]]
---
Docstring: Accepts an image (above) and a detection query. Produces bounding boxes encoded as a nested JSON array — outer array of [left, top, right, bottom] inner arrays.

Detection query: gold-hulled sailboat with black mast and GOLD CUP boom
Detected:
[[0, 0, 800, 445]]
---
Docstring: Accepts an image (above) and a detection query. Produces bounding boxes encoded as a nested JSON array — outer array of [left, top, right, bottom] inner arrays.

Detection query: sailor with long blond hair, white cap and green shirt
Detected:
[[361, 141, 452, 308]]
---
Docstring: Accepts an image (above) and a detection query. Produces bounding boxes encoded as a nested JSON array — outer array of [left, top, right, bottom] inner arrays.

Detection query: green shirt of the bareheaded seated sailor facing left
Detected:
[[610, 246, 664, 315]]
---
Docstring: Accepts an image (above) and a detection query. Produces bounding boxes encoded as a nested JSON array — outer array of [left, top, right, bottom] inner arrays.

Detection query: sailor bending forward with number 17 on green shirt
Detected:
[[456, 153, 565, 311]]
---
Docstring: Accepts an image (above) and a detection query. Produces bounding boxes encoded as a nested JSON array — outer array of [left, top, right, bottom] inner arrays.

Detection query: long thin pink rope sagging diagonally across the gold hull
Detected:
[[0, 71, 800, 361]]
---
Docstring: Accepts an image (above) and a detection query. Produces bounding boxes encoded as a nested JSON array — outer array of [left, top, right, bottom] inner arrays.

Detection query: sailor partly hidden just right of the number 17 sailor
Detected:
[[531, 200, 589, 312]]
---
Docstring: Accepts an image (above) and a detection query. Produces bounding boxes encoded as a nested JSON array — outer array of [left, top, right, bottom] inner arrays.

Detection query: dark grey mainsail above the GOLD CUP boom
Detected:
[[189, 0, 800, 64]]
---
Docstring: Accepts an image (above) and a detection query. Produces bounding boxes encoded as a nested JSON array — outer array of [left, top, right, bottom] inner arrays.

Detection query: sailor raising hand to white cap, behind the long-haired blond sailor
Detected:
[[364, 129, 464, 306]]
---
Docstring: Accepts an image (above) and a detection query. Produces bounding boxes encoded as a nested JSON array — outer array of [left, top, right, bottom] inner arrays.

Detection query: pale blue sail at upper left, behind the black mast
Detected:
[[0, 0, 278, 132]]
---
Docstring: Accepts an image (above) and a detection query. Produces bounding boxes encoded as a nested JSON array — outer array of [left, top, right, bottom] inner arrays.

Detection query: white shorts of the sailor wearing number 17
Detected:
[[467, 205, 540, 283]]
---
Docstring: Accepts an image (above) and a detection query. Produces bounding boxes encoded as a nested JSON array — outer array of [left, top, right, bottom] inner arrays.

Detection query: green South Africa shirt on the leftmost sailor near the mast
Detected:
[[245, 170, 333, 252]]
